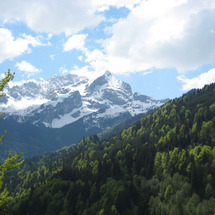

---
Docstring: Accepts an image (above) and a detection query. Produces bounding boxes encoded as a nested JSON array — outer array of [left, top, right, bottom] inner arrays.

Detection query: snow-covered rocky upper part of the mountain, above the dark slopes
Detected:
[[0, 71, 167, 130]]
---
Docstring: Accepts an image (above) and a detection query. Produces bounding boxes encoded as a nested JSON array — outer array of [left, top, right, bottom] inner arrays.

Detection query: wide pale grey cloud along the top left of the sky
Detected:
[[0, 0, 140, 35]]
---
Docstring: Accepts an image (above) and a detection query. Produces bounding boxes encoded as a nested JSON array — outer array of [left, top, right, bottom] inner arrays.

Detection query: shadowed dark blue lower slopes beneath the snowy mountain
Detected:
[[0, 110, 155, 161]]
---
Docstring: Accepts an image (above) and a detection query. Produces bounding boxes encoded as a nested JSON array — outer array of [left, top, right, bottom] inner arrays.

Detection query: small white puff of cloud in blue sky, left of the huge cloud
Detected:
[[63, 34, 87, 51]]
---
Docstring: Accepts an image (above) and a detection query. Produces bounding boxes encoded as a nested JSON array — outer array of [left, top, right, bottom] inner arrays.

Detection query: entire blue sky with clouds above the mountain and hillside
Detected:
[[0, 0, 215, 99]]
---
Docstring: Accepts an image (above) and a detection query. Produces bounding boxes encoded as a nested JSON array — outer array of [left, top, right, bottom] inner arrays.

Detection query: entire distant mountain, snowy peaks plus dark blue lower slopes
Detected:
[[0, 71, 168, 159]]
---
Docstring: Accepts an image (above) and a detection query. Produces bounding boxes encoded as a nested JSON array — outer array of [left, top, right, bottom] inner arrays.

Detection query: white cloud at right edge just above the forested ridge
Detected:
[[177, 68, 215, 90]]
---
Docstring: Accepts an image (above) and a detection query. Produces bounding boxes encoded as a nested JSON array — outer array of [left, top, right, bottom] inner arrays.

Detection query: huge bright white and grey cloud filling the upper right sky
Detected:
[[96, 0, 215, 73]]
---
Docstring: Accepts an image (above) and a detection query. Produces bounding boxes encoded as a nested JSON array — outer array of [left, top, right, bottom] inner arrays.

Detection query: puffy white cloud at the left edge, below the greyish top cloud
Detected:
[[0, 28, 43, 63]]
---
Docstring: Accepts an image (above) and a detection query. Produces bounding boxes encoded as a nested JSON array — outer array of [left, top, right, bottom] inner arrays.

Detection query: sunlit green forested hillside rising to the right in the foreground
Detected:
[[2, 84, 215, 215]]
